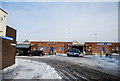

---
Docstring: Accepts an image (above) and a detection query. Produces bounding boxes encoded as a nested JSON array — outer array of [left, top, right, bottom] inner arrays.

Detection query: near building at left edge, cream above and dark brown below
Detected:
[[0, 9, 16, 70]]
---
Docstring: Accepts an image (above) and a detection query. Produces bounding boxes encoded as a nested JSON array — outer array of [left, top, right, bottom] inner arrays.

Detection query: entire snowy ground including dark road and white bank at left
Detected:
[[3, 54, 119, 81]]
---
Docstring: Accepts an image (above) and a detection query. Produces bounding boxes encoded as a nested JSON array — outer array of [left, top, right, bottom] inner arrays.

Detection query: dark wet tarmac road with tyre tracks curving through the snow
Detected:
[[19, 57, 119, 81]]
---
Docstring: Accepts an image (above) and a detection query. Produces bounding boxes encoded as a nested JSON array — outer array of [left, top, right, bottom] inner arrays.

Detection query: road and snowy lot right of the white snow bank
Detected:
[[17, 54, 119, 81]]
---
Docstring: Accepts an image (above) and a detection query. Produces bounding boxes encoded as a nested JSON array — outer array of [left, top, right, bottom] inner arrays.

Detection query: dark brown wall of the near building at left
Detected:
[[0, 26, 16, 69]]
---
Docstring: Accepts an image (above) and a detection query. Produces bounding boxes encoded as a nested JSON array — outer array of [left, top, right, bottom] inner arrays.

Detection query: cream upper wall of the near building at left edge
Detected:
[[0, 9, 7, 37]]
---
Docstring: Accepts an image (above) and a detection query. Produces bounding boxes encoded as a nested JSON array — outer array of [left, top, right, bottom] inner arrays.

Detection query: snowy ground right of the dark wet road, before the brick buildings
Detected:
[[41, 54, 119, 76]]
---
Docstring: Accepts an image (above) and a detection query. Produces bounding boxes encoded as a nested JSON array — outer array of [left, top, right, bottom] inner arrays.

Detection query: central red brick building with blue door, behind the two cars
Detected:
[[30, 41, 72, 54]]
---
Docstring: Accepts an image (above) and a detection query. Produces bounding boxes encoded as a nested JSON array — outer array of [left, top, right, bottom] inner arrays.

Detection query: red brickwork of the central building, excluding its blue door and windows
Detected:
[[31, 42, 72, 53]]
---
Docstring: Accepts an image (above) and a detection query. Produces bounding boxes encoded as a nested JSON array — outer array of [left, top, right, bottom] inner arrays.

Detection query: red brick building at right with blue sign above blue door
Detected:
[[85, 42, 120, 54]]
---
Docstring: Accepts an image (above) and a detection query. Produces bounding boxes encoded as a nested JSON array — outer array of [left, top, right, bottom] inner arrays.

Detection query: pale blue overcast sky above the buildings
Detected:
[[2, 2, 118, 42]]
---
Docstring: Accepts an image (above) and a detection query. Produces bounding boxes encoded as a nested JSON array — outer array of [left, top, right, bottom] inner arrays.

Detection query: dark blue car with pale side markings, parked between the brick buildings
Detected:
[[67, 48, 84, 56]]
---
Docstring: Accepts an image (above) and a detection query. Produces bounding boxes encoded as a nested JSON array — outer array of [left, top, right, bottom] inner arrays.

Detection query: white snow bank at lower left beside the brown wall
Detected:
[[3, 58, 61, 79]]
